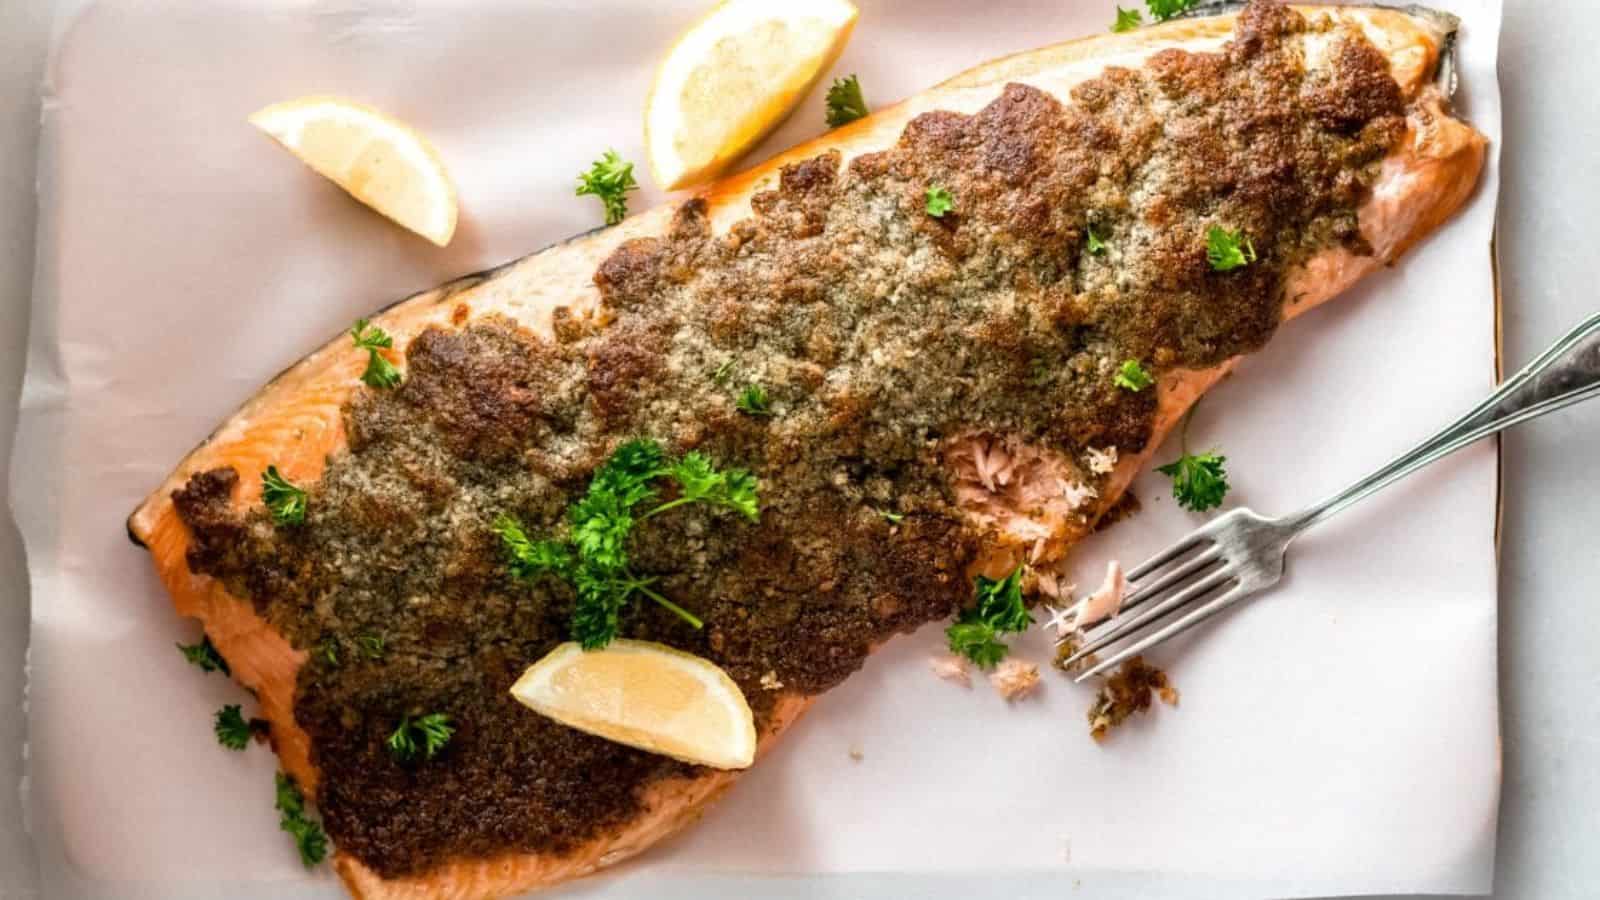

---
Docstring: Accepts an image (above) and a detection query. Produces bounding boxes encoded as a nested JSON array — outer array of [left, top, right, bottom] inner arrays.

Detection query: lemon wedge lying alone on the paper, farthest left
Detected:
[[250, 96, 456, 247]]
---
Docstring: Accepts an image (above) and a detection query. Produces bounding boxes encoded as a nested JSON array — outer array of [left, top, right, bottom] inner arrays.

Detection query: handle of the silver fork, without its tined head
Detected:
[[1285, 314, 1600, 533]]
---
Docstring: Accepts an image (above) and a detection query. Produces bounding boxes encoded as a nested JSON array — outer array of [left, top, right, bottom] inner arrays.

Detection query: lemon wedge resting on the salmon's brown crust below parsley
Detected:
[[510, 641, 755, 769]]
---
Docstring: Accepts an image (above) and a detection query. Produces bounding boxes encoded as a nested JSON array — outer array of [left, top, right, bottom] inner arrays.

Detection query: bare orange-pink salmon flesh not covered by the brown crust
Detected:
[[128, 6, 1485, 900]]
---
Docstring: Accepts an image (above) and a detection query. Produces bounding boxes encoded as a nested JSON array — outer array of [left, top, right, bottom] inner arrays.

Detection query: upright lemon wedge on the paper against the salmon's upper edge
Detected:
[[645, 0, 858, 191]]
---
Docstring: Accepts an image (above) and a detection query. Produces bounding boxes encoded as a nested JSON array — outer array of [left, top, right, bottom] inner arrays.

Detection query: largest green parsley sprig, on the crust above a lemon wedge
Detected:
[[493, 440, 760, 650]]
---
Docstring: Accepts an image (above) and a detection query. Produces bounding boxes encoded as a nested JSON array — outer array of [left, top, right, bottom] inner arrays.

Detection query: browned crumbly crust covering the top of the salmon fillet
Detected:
[[174, 5, 1403, 878]]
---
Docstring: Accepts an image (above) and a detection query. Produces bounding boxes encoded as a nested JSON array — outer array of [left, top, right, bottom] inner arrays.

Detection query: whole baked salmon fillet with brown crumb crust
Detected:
[[128, 0, 1485, 900]]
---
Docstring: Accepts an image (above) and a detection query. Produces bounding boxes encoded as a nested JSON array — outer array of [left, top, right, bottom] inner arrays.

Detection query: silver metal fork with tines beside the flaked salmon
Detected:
[[1066, 314, 1600, 681]]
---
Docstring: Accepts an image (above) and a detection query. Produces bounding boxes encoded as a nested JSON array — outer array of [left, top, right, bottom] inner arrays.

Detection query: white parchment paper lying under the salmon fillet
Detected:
[[13, 0, 1499, 897]]
